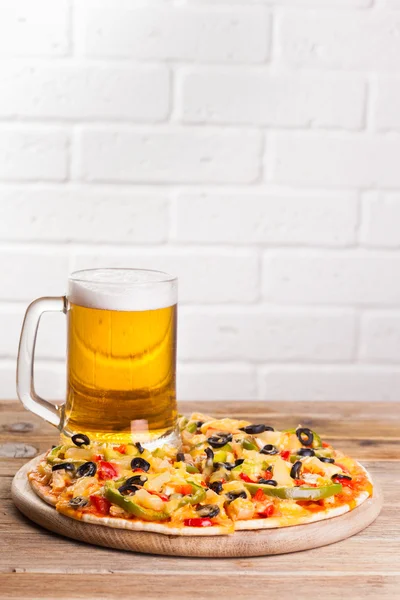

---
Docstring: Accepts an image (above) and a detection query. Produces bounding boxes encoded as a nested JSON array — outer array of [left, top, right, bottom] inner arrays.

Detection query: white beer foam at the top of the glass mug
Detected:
[[68, 269, 178, 311]]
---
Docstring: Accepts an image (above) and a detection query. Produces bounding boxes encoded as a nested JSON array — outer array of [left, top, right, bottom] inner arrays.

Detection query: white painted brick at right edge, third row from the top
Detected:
[[266, 134, 400, 188]]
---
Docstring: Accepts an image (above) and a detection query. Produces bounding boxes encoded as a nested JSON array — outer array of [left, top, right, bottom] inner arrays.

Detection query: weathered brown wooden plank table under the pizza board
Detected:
[[0, 402, 400, 600]]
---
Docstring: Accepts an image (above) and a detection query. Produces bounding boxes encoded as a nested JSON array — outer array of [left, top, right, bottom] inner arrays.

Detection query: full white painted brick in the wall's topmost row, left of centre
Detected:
[[78, 1, 270, 63]]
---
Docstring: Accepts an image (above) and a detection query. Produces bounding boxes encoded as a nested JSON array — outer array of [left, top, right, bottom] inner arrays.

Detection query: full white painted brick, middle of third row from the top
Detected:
[[80, 127, 261, 183]]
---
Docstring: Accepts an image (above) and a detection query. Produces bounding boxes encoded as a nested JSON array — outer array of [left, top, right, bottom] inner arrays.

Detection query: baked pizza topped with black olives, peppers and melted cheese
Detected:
[[28, 413, 373, 536]]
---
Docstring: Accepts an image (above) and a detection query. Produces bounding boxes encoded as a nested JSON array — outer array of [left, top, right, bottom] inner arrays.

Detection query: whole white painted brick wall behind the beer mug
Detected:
[[0, 0, 400, 401]]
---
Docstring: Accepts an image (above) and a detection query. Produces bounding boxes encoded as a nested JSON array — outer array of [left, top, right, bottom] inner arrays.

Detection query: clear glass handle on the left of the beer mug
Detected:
[[17, 296, 67, 429]]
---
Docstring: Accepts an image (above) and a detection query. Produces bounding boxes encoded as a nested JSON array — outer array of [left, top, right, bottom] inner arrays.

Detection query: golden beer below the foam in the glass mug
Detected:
[[63, 304, 177, 442]]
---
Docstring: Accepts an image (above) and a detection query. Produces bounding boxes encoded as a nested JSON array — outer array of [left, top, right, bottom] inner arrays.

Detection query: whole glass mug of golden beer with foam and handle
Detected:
[[17, 269, 178, 447]]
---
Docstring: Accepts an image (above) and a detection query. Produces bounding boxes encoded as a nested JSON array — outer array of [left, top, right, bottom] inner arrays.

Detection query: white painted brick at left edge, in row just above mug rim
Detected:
[[0, 186, 169, 244]]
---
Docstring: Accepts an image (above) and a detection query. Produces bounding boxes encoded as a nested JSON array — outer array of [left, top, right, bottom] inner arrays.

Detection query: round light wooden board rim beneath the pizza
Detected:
[[12, 457, 383, 557]]
